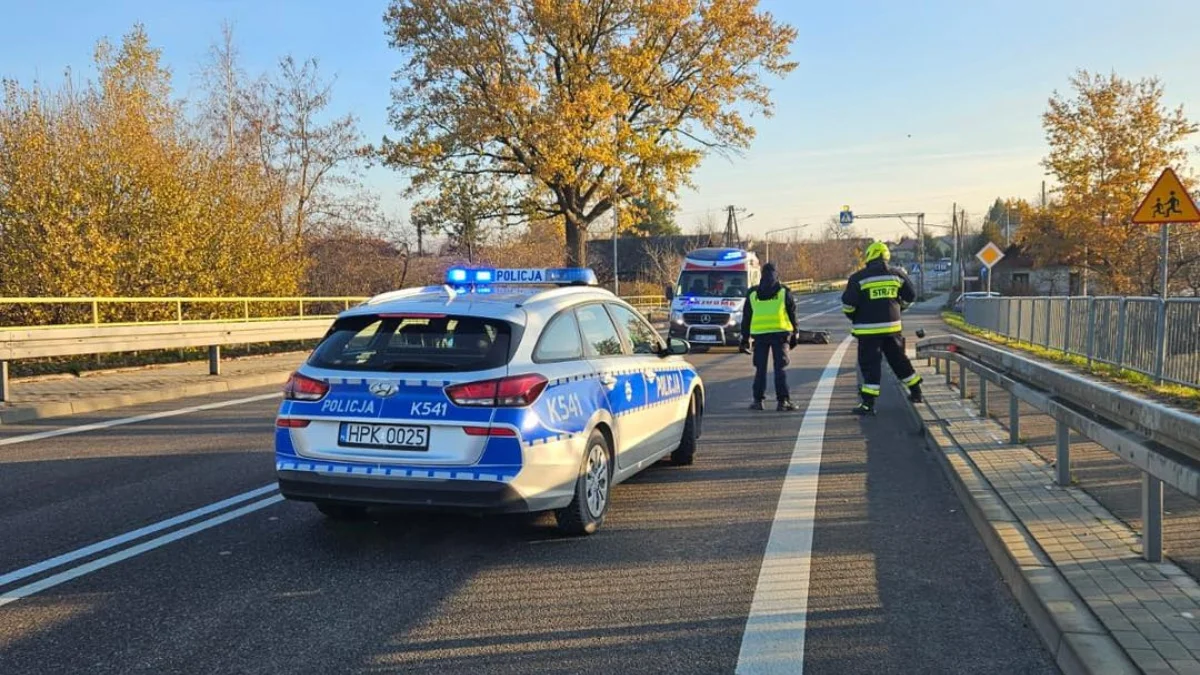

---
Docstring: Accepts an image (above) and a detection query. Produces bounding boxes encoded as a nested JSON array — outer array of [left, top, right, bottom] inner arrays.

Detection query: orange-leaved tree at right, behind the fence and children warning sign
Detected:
[[1019, 71, 1200, 294]]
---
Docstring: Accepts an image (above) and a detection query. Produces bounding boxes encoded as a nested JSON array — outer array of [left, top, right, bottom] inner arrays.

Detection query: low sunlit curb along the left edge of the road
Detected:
[[0, 368, 295, 425]]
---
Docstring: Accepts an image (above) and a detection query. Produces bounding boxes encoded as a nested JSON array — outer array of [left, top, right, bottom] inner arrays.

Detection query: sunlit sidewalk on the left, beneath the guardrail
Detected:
[[0, 352, 307, 424]]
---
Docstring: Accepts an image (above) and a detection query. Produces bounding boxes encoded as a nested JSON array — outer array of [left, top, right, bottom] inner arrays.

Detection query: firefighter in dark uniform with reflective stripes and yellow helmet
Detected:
[[841, 241, 920, 414]]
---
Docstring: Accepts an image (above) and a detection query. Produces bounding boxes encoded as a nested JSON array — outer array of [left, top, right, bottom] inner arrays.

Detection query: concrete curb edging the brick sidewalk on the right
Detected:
[[894, 372, 1141, 675]]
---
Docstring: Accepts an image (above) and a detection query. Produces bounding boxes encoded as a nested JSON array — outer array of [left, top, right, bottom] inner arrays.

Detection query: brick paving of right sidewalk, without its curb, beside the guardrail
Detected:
[[918, 357, 1200, 674]]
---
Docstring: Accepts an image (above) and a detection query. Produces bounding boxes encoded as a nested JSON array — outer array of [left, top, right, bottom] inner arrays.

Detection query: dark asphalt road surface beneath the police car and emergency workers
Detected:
[[0, 295, 1056, 675]]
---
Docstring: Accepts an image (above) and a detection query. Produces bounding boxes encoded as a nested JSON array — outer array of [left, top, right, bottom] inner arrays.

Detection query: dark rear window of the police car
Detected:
[[308, 315, 512, 372]]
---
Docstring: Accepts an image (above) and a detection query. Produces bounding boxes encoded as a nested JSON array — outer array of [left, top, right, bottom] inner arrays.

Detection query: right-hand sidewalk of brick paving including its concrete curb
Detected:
[[914, 363, 1200, 675]]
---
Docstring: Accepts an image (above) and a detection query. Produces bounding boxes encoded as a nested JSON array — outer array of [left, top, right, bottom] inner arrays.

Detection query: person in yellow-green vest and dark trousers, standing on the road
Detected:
[[742, 263, 799, 411]]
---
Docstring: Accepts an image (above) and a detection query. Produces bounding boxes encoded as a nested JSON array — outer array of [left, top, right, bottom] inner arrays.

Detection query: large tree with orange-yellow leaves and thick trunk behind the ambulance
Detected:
[[383, 0, 796, 264]]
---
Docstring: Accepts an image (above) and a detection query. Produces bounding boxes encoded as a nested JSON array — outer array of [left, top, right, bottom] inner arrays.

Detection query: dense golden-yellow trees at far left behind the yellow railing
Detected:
[[0, 29, 300, 307]]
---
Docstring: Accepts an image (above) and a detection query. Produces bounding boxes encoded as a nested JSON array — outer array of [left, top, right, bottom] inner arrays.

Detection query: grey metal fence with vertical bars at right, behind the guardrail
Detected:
[[964, 297, 1200, 387]]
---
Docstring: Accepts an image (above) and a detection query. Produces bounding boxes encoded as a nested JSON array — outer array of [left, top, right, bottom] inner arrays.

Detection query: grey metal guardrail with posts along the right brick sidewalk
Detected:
[[917, 335, 1200, 562]]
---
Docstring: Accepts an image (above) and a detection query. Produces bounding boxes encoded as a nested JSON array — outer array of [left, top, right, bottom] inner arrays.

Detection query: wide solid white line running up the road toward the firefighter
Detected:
[[736, 333, 852, 675]]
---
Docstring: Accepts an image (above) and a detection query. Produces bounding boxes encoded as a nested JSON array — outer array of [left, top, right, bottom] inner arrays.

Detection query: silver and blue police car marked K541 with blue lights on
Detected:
[[275, 268, 704, 534]]
